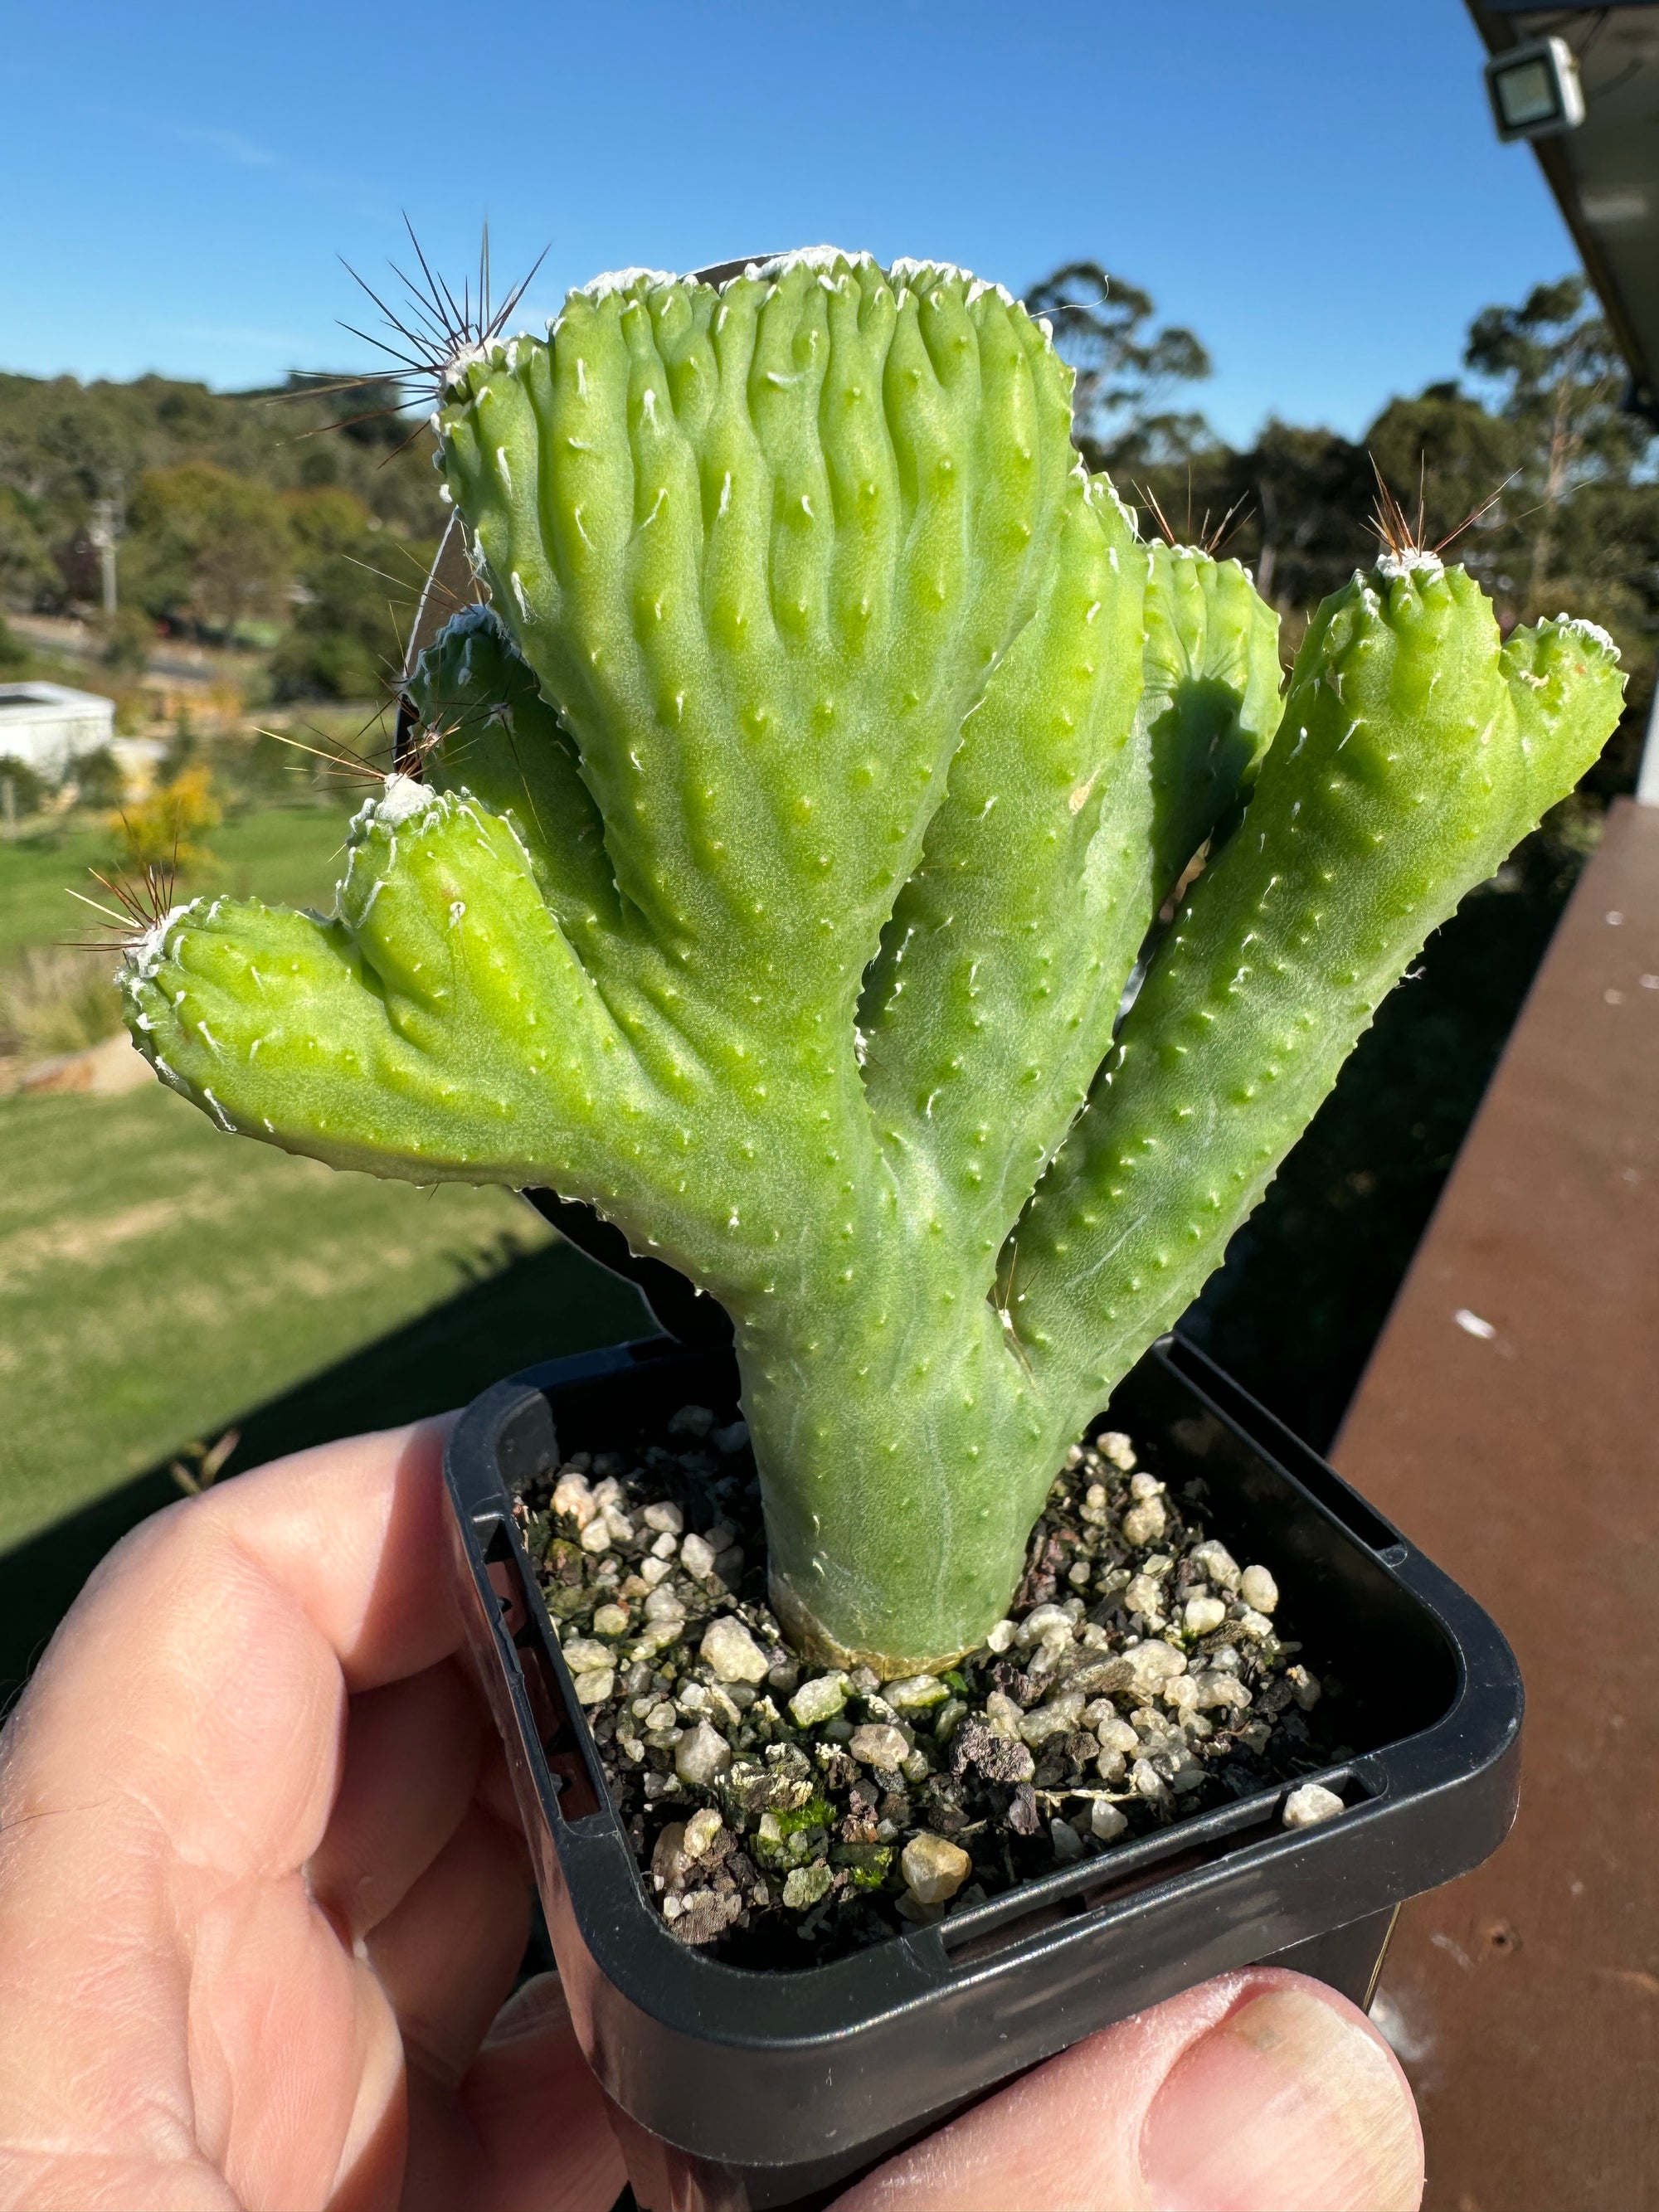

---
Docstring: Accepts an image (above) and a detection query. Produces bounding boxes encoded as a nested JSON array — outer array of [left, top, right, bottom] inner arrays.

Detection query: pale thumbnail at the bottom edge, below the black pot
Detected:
[[1141, 1989, 1423, 2212]]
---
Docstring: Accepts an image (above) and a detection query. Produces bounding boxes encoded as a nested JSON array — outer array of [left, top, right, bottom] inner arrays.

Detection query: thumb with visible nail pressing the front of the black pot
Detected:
[[834, 1969, 1423, 2212]]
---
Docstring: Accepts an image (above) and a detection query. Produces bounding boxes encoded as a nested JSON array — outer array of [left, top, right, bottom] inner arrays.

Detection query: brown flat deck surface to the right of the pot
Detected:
[[1334, 800, 1659, 2212]]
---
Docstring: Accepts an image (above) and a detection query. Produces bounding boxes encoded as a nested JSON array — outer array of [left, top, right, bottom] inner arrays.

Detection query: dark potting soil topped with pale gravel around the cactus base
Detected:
[[515, 1405, 1350, 1969]]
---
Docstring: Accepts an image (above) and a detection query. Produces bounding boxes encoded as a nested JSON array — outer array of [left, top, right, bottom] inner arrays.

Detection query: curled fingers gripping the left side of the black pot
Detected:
[[0, 1422, 624, 2212]]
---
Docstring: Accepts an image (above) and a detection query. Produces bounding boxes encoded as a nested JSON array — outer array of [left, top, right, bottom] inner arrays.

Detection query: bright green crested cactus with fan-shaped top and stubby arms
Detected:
[[122, 248, 1622, 1675]]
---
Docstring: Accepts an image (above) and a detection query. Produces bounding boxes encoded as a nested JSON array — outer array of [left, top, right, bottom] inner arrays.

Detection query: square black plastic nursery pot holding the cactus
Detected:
[[445, 1336, 1522, 2212]]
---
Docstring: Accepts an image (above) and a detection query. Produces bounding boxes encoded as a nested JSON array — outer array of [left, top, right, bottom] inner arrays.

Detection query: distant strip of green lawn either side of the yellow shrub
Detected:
[[0, 807, 362, 965]]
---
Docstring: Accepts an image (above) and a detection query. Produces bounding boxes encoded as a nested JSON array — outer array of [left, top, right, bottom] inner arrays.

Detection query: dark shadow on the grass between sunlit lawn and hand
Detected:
[[0, 1243, 653, 1714]]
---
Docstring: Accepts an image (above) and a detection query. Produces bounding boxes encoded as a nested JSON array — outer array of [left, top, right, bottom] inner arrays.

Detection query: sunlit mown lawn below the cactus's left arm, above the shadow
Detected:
[[0, 1086, 559, 1548]]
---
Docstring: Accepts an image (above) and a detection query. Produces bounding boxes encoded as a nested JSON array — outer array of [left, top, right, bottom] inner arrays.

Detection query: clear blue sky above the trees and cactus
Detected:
[[0, 0, 1573, 438]]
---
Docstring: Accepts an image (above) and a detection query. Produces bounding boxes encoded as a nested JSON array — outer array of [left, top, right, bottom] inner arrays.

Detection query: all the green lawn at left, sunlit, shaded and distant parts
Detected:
[[0, 809, 650, 1712]]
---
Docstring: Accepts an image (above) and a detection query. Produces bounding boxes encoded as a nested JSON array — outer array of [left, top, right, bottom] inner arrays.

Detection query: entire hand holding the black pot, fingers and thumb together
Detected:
[[0, 1425, 1423, 2212]]
